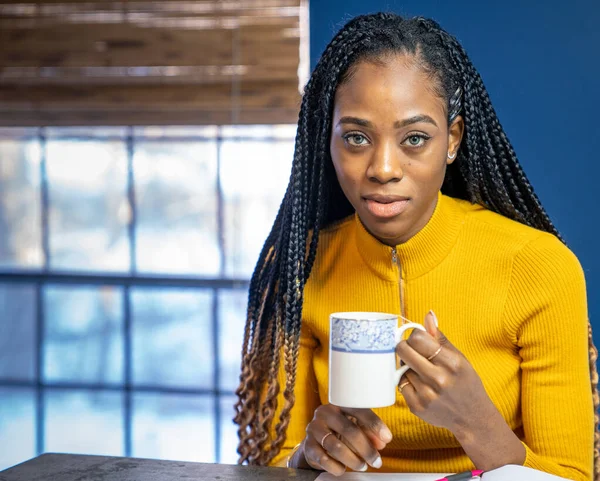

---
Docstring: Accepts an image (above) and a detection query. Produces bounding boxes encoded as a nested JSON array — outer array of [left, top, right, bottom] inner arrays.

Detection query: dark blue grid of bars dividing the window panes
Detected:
[[0, 126, 293, 463]]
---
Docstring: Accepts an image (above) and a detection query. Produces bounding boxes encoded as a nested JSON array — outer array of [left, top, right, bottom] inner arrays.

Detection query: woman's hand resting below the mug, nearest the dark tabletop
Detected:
[[303, 404, 392, 476]]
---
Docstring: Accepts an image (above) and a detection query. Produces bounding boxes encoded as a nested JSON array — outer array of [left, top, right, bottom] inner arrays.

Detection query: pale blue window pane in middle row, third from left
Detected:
[[132, 288, 214, 389]]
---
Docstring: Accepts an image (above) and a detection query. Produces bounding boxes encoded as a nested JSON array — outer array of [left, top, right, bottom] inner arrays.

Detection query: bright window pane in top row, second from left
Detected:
[[47, 140, 130, 271]]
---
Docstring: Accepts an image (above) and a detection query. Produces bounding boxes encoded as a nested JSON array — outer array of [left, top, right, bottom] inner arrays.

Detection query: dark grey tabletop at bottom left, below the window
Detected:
[[0, 454, 320, 481]]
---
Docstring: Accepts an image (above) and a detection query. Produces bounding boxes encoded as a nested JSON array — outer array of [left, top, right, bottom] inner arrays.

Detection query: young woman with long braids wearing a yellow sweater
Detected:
[[235, 14, 598, 480]]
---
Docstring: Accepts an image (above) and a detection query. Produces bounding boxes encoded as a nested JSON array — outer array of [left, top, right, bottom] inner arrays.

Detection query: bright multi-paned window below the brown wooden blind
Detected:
[[0, 125, 295, 469]]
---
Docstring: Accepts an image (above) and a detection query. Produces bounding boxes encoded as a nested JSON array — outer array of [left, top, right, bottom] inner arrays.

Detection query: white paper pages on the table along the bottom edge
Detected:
[[316, 464, 568, 481]]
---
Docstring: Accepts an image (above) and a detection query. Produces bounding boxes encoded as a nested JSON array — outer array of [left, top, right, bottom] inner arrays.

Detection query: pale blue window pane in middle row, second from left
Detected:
[[43, 286, 124, 383]]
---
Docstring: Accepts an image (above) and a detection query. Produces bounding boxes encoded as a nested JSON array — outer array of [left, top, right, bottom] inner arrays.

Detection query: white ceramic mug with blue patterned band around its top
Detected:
[[329, 312, 425, 408]]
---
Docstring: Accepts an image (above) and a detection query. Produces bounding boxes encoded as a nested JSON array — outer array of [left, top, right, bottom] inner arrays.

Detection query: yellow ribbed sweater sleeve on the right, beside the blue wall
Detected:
[[505, 234, 594, 481]]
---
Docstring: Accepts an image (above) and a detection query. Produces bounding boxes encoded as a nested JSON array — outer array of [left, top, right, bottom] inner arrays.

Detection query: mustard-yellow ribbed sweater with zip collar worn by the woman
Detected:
[[273, 194, 594, 480]]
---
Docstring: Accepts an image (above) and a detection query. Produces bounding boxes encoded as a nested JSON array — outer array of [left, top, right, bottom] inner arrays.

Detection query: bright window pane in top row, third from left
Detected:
[[134, 141, 221, 276]]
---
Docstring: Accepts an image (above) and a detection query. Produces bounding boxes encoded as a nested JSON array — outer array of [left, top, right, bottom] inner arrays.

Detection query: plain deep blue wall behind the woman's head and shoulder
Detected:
[[310, 0, 600, 345]]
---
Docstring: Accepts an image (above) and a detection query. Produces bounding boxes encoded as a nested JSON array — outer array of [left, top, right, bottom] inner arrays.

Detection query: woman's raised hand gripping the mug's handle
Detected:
[[396, 312, 497, 435]]
